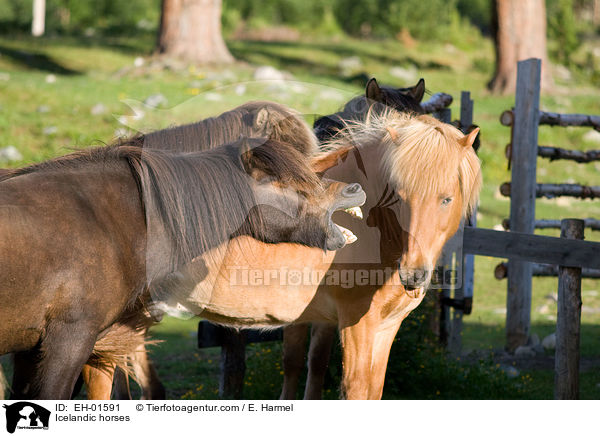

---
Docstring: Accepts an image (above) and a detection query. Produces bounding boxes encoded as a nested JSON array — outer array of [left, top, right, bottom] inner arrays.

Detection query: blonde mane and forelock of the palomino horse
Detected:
[[324, 109, 481, 215]]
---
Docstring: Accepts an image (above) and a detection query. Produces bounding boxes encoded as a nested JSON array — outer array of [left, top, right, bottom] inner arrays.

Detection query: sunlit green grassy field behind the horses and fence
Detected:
[[0, 30, 600, 398]]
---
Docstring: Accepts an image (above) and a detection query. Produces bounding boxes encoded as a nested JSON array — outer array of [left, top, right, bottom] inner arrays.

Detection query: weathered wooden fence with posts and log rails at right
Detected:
[[465, 59, 600, 399]]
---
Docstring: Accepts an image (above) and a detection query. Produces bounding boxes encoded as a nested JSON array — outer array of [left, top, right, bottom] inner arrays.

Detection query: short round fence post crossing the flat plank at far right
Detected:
[[554, 219, 584, 400]]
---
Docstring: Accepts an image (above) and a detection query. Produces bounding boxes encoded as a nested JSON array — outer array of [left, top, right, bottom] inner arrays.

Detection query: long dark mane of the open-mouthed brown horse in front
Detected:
[[0, 138, 322, 280]]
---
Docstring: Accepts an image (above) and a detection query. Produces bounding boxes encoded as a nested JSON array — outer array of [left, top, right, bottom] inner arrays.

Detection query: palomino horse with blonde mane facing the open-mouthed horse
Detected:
[[144, 110, 481, 399]]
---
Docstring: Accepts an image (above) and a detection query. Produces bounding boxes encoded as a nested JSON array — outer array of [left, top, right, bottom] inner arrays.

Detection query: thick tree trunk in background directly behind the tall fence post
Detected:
[[488, 0, 552, 94]]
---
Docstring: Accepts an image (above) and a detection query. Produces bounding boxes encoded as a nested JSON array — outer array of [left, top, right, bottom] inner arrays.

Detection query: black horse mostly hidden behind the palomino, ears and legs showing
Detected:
[[280, 78, 425, 400]]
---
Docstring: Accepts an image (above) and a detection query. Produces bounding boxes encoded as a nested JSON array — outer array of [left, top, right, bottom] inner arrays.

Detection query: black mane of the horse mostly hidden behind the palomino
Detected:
[[314, 86, 424, 142]]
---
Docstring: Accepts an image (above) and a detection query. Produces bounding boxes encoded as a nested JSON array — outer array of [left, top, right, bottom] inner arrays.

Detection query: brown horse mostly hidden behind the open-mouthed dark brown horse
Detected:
[[75, 101, 338, 399]]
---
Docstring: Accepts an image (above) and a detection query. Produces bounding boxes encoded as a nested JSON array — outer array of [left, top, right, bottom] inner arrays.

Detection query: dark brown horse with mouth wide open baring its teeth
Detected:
[[0, 140, 364, 399]]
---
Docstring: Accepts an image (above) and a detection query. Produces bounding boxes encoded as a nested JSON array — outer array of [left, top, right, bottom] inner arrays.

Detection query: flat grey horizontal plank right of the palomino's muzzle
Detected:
[[463, 227, 600, 271]]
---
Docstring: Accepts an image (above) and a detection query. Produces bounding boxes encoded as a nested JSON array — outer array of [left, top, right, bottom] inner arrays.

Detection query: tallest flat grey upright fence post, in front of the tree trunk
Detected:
[[506, 59, 541, 351]]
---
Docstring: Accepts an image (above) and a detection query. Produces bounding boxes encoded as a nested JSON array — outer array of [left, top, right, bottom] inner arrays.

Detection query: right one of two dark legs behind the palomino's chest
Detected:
[[304, 323, 337, 400]]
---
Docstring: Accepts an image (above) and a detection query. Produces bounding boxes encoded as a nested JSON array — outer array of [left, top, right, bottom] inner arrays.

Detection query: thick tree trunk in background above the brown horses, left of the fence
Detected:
[[158, 0, 233, 64]]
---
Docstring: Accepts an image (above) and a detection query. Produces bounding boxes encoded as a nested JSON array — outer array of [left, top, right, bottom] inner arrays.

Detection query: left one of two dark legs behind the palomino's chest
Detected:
[[279, 324, 309, 400]]
